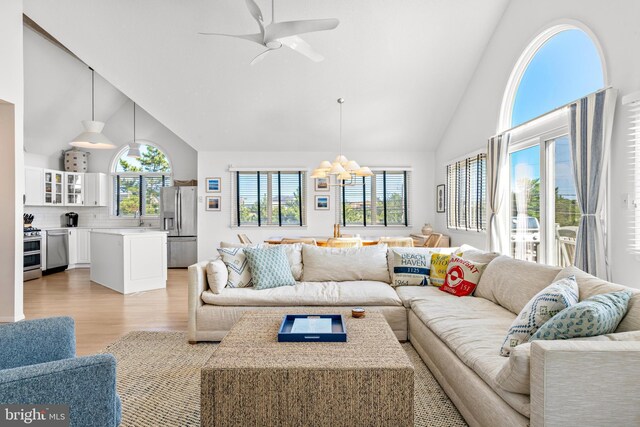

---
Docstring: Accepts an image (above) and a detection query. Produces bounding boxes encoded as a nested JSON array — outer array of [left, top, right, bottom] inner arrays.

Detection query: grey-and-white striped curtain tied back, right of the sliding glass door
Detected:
[[569, 89, 618, 279]]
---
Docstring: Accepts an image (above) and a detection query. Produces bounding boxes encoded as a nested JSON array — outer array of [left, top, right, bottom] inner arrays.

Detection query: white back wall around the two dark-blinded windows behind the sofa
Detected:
[[198, 150, 435, 259]]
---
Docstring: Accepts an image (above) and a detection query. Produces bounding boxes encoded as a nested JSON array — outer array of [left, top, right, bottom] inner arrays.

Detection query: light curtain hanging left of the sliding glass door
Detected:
[[487, 133, 510, 254]]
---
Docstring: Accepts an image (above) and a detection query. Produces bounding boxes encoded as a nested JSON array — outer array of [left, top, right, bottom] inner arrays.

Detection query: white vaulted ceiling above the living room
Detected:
[[24, 0, 508, 151]]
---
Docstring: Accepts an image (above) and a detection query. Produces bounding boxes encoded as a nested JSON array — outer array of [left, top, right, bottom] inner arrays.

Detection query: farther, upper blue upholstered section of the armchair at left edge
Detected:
[[0, 317, 76, 369]]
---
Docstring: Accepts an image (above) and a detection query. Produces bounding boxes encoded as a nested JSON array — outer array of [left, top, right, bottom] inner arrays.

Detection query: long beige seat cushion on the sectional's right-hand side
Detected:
[[409, 287, 529, 416]]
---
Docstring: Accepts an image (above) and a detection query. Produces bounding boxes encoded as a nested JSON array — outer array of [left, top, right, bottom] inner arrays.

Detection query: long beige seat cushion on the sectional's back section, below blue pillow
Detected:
[[202, 280, 400, 307]]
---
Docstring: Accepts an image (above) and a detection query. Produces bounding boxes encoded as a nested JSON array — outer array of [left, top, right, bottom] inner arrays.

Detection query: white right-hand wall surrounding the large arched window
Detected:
[[436, 0, 640, 287]]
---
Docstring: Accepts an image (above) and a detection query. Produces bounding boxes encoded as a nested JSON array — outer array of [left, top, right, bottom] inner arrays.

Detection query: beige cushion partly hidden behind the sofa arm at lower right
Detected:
[[496, 331, 640, 394]]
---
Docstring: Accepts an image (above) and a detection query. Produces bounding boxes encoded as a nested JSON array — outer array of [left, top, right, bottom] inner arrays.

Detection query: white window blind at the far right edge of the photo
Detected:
[[622, 93, 640, 254]]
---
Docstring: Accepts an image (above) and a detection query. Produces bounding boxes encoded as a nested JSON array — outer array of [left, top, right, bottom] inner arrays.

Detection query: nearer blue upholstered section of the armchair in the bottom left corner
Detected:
[[0, 354, 121, 427]]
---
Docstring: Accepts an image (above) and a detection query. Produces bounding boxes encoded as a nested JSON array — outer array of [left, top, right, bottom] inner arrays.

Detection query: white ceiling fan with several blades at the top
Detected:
[[200, 0, 340, 65]]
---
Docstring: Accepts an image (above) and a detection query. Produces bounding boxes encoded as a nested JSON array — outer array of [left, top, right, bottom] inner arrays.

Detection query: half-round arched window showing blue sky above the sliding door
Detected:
[[499, 24, 606, 130]]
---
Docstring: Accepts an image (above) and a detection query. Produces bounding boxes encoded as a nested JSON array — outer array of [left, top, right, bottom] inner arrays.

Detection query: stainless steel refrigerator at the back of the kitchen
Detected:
[[160, 187, 198, 268]]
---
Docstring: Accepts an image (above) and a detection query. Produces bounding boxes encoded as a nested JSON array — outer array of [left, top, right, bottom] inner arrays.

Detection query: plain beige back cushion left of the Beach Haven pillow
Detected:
[[302, 245, 391, 283]]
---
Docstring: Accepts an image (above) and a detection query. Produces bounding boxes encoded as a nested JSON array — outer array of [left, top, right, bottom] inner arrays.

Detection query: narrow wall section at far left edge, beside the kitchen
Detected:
[[0, 0, 24, 322]]
